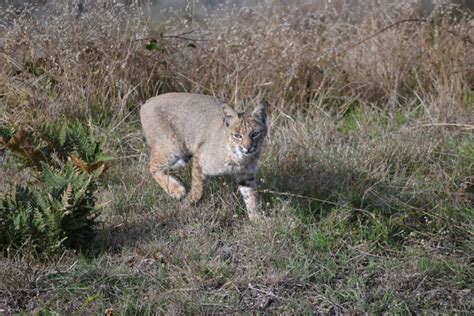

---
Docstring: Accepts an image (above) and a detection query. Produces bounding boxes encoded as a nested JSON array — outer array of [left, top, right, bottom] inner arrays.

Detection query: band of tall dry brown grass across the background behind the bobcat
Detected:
[[0, 2, 474, 121]]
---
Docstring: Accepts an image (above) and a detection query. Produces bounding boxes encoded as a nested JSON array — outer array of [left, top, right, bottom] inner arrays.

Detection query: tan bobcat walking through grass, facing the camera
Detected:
[[140, 93, 268, 220]]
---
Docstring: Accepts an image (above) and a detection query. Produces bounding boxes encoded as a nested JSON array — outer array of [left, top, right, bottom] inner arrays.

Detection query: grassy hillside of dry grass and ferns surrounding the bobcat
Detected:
[[0, 1, 474, 315]]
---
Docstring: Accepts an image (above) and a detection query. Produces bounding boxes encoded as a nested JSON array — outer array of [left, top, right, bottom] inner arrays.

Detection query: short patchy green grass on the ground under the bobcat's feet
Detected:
[[3, 104, 473, 315]]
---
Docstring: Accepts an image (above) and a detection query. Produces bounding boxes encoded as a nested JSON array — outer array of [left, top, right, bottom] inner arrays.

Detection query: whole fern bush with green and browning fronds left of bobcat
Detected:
[[0, 123, 109, 257]]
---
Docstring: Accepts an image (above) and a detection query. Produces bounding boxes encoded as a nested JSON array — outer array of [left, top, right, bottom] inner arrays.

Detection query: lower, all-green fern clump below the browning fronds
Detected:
[[0, 162, 99, 255]]
